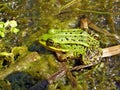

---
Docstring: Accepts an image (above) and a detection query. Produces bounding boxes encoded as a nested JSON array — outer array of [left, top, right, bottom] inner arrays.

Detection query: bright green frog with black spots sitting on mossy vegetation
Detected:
[[39, 29, 102, 66]]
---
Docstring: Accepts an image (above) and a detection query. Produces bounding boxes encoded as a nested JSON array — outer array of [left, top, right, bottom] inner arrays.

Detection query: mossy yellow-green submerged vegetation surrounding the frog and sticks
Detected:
[[0, 0, 120, 90]]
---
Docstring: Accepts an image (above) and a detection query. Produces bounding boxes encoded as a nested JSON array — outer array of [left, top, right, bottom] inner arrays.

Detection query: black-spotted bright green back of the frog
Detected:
[[50, 29, 99, 47]]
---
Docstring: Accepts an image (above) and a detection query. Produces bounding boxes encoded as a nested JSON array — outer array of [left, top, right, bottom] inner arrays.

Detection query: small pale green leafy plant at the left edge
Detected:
[[0, 20, 19, 37]]
